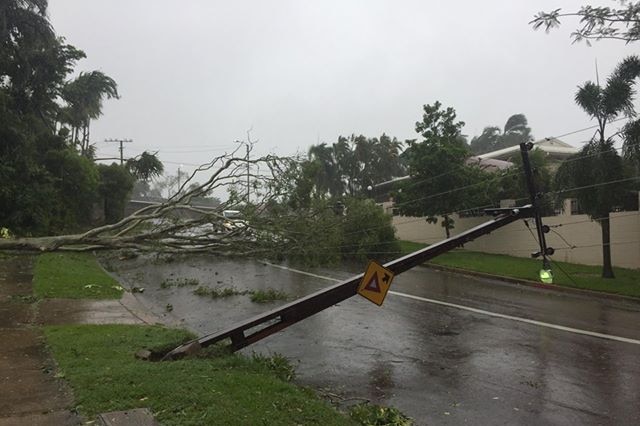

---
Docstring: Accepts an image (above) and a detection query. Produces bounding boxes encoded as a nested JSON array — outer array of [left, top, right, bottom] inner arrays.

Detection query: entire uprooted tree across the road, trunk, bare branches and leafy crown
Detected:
[[0, 146, 397, 263]]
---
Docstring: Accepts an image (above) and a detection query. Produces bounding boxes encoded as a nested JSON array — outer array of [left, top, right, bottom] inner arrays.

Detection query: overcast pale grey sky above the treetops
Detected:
[[49, 0, 638, 176]]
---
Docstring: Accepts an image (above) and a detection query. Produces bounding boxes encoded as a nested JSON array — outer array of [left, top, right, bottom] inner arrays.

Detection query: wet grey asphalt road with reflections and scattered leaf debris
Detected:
[[114, 258, 640, 425]]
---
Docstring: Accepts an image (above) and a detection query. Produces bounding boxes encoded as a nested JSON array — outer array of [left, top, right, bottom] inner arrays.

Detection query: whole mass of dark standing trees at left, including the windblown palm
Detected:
[[0, 0, 154, 235]]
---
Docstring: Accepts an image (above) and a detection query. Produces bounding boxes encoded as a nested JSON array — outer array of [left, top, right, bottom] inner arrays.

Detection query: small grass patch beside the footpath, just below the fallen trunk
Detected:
[[33, 253, 122, 299]]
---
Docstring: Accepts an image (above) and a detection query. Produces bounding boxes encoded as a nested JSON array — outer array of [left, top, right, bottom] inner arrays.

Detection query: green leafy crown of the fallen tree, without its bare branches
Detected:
[[263, 159, 399, 264]]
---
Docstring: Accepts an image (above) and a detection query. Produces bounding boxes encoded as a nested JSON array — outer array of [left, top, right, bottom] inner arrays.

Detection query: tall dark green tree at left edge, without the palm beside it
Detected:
[[0, 0, 120, 236]]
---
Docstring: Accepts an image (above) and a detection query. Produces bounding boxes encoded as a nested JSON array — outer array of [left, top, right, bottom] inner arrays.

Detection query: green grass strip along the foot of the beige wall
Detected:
[[400, 241, 640, 297]]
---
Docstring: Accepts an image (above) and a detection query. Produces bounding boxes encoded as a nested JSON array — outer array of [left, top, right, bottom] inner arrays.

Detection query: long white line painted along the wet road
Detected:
[[265, 262, 640, 345]]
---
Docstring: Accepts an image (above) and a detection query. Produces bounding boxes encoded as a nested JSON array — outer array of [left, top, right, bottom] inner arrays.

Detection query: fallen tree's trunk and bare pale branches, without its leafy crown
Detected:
[[0, 152, 291, 255]]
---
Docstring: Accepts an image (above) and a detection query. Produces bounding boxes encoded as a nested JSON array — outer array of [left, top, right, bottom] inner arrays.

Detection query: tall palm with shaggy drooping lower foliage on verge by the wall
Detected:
[[556, 56, 640, 278]]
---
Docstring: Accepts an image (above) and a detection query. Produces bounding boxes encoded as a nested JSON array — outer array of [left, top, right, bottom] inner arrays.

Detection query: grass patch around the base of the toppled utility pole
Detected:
[[44, 325, 356, 425]]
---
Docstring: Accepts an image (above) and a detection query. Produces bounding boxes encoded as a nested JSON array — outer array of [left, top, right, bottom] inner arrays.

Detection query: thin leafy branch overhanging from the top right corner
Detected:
[[529, 0, 640, 43]]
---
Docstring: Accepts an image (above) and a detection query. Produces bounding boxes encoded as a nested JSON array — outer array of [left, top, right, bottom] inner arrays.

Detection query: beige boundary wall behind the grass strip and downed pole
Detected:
[[393, 211, 640, 269]]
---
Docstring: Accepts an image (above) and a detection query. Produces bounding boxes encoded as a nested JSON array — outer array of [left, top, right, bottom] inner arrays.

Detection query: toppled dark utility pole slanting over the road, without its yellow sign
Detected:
[[163, 205, 533, 360]]
